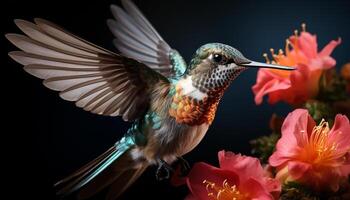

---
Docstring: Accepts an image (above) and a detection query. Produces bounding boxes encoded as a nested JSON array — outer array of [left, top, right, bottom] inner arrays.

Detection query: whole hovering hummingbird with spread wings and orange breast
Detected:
[[6, 0, 294, 200]]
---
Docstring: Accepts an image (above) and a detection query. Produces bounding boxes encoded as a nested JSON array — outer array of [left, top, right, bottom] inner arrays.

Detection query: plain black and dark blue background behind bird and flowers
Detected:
[[1, 0, 350, 199]]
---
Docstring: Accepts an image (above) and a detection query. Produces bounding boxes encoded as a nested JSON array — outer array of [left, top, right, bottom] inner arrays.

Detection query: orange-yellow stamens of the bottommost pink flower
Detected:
[[203, 179, 247, 200]]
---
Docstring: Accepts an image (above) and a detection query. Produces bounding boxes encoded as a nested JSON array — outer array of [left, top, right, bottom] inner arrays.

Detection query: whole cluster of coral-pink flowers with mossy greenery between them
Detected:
[[173, 25, 350, 200]]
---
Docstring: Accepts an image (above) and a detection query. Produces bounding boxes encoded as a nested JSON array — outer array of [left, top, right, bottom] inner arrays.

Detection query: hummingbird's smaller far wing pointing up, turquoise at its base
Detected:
[[107, 0, 186, 78]]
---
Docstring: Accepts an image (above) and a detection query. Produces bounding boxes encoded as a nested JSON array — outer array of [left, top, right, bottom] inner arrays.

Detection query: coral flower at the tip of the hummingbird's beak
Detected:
[[252, 26, 341, 105]]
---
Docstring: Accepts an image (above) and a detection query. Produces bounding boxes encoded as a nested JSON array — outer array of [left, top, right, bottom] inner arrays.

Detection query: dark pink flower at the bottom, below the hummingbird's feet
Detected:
[[178, 151, 281, 200]]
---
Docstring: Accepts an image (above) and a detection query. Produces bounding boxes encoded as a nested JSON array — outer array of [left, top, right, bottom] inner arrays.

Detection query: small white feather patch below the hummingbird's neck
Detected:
[[176, 76, 208, 100]]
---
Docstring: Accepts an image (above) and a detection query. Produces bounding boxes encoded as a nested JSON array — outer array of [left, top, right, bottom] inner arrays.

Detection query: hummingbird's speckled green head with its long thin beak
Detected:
[[187, 43, 294, 93]]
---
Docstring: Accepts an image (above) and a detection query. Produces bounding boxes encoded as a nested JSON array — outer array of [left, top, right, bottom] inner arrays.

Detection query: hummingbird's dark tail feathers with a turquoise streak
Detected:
[[55, 137, 148, 200]]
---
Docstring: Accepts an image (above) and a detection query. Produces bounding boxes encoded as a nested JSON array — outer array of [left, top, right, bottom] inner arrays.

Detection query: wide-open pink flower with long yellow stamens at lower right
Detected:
[[269, 109, 350, 191]]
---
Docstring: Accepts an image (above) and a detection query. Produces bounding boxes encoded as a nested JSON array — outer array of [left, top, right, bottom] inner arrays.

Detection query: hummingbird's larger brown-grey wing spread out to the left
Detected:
[[6, 19, 166, 121]]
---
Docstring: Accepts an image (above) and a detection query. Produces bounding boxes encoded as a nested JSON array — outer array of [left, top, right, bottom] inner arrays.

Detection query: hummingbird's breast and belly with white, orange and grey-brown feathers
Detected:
[[136, 79, 219, 162]]
